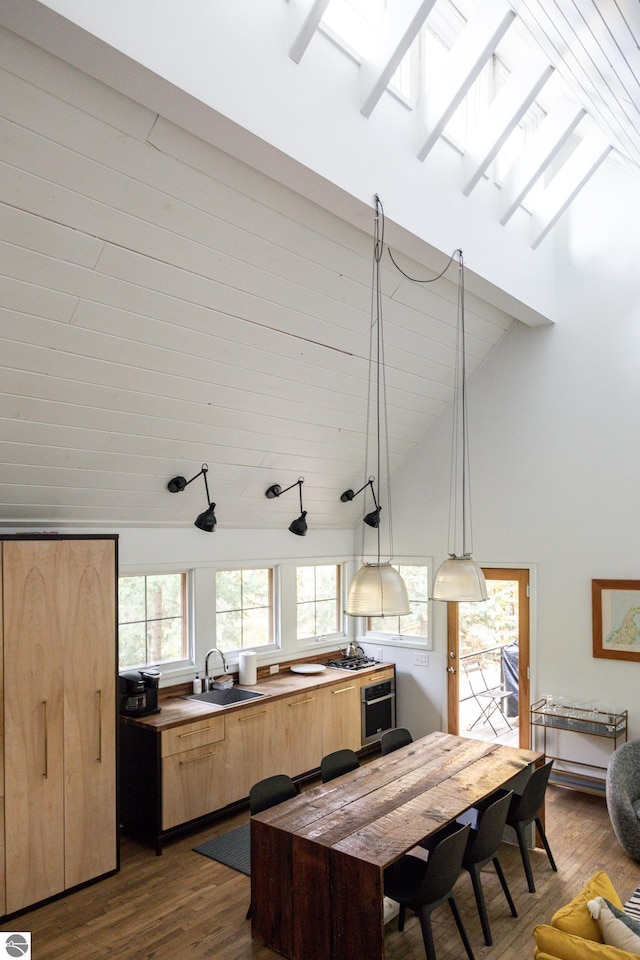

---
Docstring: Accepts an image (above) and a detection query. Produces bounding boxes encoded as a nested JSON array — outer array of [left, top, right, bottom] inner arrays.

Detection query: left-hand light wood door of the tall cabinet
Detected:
[[3, 541, 64, 913]]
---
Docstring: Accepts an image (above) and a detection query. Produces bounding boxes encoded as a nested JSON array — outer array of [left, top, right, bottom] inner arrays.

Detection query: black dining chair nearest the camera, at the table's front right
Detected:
[[384, 823, 475, 960]]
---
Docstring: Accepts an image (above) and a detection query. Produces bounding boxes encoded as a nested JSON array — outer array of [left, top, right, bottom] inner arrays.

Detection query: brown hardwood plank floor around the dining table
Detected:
[[1, 786, 640, 960]]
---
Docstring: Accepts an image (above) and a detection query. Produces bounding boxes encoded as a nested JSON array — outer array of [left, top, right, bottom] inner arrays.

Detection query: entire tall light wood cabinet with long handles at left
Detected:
[[0, 536, 118, 914]]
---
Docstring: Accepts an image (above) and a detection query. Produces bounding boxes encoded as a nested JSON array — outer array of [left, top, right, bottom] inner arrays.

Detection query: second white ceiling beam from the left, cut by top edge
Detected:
[[360, 0, 435, 117]]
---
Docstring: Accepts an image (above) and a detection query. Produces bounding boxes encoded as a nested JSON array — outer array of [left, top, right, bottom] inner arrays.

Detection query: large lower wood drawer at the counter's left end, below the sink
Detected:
[[162, 740, 230, 830]]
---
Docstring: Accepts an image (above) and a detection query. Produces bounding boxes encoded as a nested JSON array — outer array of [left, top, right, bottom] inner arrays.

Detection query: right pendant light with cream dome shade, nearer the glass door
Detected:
[[433, 250, 487, 602]]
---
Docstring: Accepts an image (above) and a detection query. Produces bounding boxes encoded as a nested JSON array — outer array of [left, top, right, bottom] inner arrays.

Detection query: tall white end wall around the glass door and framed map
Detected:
[[394, 156, 640, 737]]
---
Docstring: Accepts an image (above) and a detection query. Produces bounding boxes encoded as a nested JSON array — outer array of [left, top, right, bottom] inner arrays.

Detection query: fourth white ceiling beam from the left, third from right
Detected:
[[462, 56, 553, 197]]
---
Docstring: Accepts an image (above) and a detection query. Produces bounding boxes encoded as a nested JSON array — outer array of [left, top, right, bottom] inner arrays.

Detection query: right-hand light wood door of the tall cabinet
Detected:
[[61, 540, 117, 887]]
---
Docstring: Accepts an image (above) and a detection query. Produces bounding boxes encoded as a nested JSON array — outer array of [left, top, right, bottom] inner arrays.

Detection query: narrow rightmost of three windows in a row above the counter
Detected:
[[296, 564, 342, 640]]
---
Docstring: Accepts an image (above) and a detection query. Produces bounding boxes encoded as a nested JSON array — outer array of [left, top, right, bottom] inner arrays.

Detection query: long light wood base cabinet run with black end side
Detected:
[[119, 665, 394, 853]]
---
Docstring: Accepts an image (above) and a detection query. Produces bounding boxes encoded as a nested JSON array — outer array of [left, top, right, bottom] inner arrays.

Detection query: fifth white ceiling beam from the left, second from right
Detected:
[[500, 99, 586, 226]]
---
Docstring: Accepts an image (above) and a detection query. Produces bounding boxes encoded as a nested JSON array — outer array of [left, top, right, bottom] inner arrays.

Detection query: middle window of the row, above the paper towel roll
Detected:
[[216, 568, 273, 653]]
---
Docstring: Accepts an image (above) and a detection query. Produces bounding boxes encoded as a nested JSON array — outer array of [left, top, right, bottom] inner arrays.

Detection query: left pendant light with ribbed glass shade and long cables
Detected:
[[340, 194, 411, 617]]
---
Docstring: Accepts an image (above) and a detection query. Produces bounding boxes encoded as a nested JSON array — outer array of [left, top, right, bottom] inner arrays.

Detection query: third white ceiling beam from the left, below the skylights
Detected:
[[418, 0, 515, 160]]
